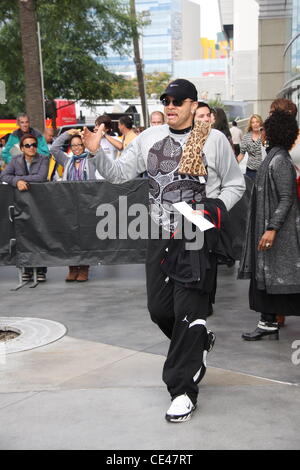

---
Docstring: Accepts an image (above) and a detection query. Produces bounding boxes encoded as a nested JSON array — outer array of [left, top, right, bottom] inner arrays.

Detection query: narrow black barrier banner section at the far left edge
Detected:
[[0, 184, 16, 266]]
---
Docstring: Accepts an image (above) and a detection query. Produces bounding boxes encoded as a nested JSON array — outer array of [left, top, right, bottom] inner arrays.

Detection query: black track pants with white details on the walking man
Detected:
[[146, 240, 209, 403]]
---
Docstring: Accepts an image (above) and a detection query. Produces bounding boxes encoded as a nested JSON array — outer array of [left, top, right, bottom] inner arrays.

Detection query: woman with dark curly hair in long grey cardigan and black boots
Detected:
[[239, 110, 300, 341]]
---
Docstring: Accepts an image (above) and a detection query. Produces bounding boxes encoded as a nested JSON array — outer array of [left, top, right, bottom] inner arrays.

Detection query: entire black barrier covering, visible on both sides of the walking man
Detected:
[[0, 178, 251, 267]]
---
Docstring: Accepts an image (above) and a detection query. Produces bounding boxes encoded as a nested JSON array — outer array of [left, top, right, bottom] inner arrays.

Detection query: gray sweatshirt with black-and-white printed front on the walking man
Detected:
[[95, 124, 245, 229]]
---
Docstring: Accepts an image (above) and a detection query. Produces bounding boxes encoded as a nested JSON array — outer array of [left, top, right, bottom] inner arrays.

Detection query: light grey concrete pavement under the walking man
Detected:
[[0, 266, 300, 450]]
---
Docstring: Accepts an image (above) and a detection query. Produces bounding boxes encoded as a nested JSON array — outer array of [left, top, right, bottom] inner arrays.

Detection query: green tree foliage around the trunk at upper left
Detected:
[[0, 0, 132, 114]]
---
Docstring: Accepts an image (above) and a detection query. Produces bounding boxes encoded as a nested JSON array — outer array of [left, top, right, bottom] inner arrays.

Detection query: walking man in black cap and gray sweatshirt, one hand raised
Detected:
[[85, 79, 245, 422]]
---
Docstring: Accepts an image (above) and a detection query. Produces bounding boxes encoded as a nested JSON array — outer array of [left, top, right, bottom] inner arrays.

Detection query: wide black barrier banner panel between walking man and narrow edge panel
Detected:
[[9, 179, 148, 266]]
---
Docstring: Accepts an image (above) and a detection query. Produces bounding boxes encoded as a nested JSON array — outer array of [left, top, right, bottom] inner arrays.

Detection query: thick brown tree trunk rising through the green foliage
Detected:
[[19, 0, 44, 131]]
